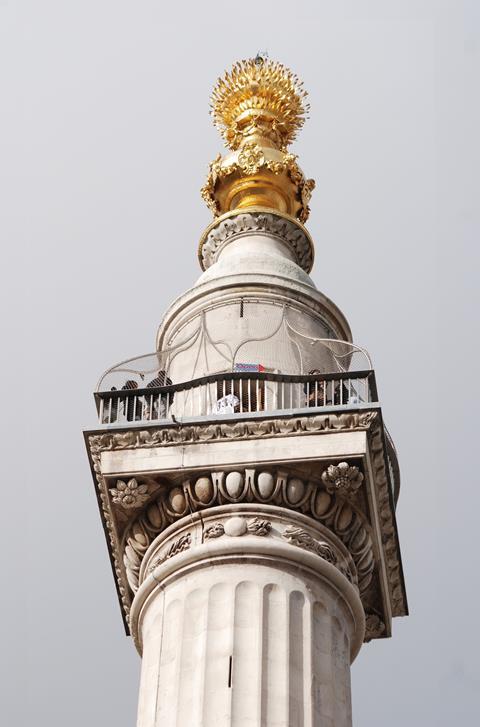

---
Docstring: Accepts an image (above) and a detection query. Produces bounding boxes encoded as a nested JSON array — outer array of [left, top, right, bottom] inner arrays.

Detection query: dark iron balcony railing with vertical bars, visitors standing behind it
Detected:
[[95, 370, 378, 425]]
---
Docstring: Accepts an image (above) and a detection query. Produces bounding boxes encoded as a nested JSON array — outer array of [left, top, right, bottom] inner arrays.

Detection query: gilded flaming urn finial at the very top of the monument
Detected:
[[202, 56, 315, 222]]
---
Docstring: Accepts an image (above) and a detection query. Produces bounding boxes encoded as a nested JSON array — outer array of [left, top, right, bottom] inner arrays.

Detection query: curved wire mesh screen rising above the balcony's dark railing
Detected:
[[97, 299, 372, 391]]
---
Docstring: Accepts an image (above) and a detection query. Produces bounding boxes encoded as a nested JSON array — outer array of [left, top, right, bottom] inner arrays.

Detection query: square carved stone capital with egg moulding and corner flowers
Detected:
[[87, 409, 406, 638]]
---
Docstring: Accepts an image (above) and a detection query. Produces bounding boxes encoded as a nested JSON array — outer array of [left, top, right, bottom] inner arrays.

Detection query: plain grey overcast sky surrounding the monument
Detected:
[[0, 0, 480, 727]]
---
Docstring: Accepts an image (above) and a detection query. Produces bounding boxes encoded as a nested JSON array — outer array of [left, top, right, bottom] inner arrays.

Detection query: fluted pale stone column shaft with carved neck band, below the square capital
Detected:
[[130, 505, 365, 727]]
